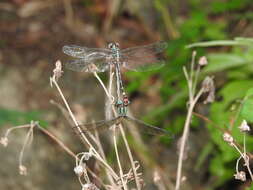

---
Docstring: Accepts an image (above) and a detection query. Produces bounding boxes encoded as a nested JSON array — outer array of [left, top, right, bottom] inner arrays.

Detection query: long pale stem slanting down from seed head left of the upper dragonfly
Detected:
[[51, 78, 118, 179]]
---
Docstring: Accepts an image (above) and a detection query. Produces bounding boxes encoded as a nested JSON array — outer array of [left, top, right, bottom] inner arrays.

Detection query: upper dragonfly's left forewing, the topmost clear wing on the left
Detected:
[[62, 45, 112, 59]]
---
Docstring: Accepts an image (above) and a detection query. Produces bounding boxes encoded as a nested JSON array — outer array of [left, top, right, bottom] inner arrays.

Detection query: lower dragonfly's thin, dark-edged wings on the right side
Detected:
[[124, 116, 173, 138]]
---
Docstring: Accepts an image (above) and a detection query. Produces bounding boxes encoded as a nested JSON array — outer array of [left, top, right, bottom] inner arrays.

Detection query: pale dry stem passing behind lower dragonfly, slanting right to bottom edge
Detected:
[[95, 70, 141, 190]]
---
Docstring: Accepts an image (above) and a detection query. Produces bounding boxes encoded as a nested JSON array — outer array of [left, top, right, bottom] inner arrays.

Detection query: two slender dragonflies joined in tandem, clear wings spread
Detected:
[[63, 42, 170, 135]]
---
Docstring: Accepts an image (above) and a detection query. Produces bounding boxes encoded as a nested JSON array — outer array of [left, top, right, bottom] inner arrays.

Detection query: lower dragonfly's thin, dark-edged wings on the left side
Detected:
[[73, 117, 122, 133]]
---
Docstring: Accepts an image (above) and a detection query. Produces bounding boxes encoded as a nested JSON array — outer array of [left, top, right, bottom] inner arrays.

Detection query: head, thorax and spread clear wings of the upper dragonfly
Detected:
[[62, 42, 167, 72]]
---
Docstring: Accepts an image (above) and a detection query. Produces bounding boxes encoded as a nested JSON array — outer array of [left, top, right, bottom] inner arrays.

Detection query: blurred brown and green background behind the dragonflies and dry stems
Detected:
[[0, 0, 253, 190]]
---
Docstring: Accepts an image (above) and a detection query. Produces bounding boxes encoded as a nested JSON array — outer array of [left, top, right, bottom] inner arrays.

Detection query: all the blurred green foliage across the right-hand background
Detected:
[[127, 0, 253, 189]]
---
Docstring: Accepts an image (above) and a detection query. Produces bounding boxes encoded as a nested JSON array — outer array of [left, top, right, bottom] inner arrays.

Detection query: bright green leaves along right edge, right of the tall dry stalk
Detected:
[[186, 38, 253, 186]]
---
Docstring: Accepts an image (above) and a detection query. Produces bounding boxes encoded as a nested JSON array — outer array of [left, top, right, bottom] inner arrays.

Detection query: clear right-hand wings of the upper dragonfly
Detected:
[[121, 42, 168, 71]]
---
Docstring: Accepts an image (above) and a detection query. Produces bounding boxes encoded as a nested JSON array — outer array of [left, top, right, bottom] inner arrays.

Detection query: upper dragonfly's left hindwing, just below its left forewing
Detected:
[[66, 57, 109, 73]]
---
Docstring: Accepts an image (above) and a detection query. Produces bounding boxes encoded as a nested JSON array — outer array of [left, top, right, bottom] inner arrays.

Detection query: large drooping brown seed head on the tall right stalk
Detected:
[[202, 76, 215, 104]]
